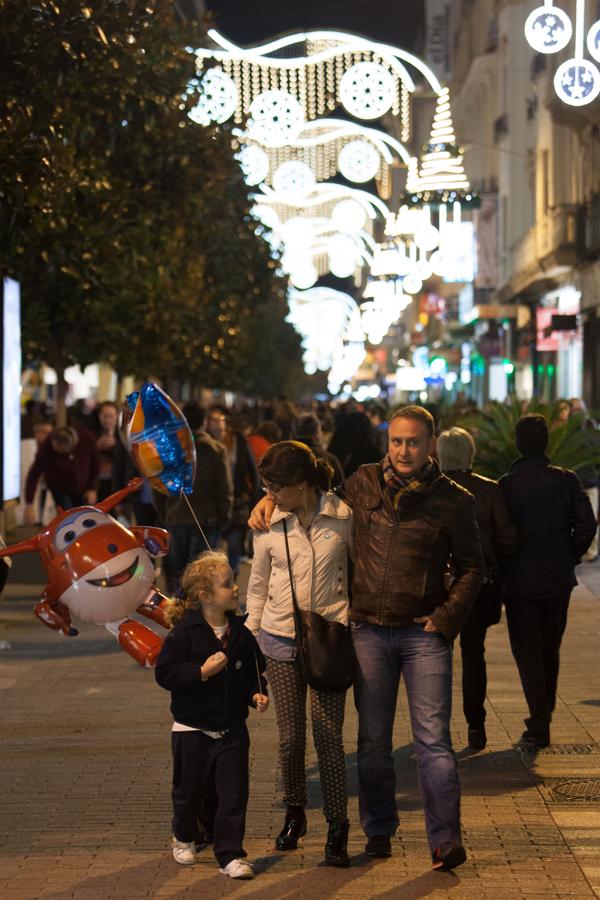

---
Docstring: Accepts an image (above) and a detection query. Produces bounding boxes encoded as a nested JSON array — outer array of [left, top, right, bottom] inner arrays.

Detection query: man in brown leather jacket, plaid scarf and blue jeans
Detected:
[[343, 406, 483, 869]]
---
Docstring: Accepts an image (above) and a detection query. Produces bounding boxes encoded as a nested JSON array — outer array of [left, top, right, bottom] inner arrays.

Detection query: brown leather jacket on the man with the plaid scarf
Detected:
[[343, 463, 483, 640]]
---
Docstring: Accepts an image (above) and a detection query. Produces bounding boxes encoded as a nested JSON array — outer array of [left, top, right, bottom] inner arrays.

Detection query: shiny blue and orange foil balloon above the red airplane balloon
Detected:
[[121, 382, 196, 496]]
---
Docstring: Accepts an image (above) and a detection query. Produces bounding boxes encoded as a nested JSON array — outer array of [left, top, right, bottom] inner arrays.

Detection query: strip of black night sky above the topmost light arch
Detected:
[[206, 0, 423, 50]]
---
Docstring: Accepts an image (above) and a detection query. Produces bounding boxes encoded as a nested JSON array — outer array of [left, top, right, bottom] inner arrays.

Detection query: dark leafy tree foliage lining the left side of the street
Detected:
[[0, 0, 300, 412]]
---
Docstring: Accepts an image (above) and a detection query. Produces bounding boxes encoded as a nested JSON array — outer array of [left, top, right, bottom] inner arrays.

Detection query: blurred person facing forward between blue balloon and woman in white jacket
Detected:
[[206, 405, 260, 578]]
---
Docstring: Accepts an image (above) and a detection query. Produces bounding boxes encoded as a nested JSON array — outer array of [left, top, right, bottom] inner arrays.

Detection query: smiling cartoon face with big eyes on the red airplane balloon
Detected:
[[39, 506, 154, 625]]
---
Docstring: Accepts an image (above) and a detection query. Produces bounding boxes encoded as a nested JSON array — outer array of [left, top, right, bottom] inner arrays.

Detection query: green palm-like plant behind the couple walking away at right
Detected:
[[459, 398, 600, 478]]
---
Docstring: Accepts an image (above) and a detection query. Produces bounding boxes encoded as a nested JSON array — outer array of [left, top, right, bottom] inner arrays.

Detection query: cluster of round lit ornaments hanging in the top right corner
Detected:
[[525, 0, 600, 106]]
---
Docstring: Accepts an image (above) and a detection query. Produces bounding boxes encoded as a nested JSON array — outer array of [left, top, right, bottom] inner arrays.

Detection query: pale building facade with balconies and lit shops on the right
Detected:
[[450, 0, 600, 408]]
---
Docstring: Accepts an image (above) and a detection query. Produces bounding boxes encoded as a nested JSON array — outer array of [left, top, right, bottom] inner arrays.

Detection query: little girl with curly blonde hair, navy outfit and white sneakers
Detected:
[[156, 551, 269, 878]]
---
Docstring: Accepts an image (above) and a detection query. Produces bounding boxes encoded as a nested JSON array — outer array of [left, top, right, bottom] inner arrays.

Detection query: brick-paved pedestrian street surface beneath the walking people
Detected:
[[0, 557, 600, 900]]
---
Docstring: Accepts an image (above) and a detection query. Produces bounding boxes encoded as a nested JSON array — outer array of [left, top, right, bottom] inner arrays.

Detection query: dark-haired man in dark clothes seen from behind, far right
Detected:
[[500, 414, 598, 752]]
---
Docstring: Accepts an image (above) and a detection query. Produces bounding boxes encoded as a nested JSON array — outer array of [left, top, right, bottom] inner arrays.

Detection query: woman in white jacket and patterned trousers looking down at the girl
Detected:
[[246, 441, 352, 867]]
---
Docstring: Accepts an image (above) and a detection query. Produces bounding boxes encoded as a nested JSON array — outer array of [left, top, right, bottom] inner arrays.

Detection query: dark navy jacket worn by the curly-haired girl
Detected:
[[155, 609, 267, 731]]
